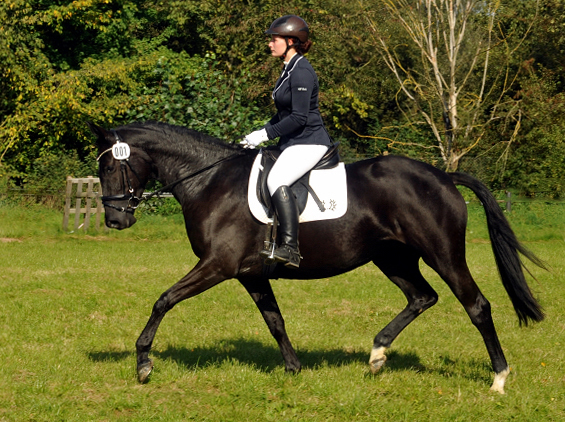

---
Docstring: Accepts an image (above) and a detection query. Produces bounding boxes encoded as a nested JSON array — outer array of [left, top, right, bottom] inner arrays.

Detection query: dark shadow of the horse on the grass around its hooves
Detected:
[[88, 339, 492, 383]]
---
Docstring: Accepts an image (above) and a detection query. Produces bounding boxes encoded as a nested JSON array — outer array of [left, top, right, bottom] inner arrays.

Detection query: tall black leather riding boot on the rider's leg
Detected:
[[271, 186, 301, 268]]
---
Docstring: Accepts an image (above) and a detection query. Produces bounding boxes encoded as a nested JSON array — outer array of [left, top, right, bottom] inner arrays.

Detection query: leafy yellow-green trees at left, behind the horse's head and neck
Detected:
[[0, 0, 259, 185]]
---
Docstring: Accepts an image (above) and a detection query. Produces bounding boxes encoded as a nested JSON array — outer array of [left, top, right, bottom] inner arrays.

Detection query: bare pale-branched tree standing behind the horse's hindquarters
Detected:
[[368, 0, 537, 171]]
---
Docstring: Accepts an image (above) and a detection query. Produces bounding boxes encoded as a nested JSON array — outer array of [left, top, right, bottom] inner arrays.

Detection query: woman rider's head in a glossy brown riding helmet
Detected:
[[265, 15, 312, 58]]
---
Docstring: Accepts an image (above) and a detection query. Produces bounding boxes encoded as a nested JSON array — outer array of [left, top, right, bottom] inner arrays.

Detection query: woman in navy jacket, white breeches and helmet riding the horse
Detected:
[[241, 15, 332, 268]]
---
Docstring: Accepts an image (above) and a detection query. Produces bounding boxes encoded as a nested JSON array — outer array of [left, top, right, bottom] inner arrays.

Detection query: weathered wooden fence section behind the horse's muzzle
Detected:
[[63, 176, 108, 231]]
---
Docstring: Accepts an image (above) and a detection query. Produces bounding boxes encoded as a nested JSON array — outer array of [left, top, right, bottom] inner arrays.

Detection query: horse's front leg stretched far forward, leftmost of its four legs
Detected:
[[135, 261, 228, 382]]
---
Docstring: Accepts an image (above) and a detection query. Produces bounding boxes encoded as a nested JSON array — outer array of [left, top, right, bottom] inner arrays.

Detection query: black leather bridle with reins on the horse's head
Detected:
[[96, 130, 243, 214]]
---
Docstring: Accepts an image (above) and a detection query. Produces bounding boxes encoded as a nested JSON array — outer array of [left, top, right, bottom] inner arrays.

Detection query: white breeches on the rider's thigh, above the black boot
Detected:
[[267, 144, 328, 196]]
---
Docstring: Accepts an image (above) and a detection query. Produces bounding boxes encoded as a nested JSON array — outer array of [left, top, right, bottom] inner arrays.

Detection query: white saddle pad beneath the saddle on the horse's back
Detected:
[[247, 152, 347, 224]]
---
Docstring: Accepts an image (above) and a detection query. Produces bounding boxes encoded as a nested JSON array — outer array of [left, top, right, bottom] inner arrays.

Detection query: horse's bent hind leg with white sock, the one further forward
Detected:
[[369, 245, 438, 373]]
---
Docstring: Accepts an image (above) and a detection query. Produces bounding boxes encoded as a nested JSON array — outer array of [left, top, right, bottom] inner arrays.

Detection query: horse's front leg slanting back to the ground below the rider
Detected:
[[239, 278, 300, 372]]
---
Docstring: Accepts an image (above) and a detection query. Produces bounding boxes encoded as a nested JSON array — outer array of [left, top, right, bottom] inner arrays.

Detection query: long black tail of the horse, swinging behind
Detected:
[[449, 173, 546, 325]]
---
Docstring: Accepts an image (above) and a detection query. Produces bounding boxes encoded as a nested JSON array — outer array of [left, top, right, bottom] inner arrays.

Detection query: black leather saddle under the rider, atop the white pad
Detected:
[[257, 142, 340, 217]]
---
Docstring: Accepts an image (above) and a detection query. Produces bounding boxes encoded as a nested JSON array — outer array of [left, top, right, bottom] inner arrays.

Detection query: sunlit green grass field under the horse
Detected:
[[0, 204, 565, 422]]
